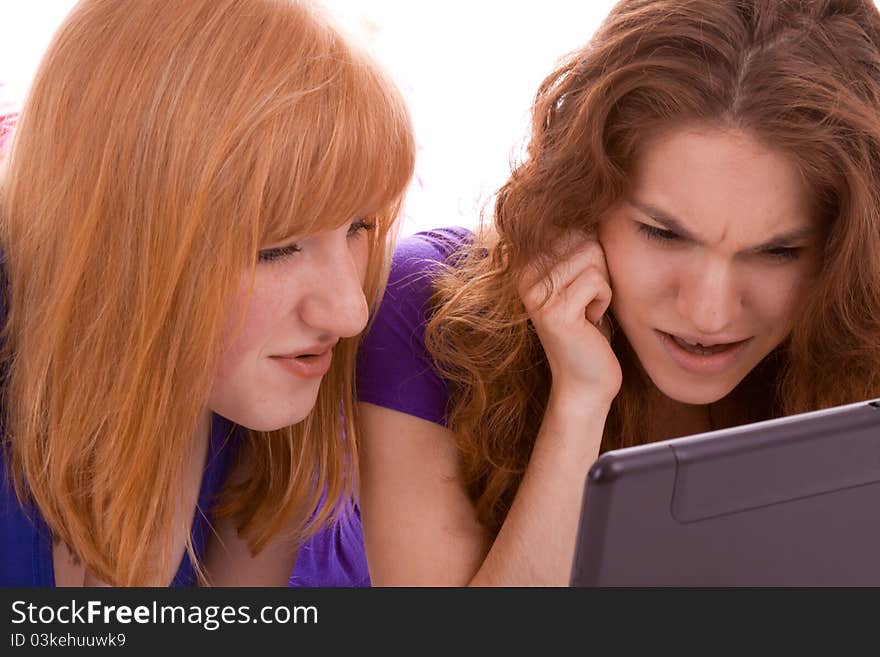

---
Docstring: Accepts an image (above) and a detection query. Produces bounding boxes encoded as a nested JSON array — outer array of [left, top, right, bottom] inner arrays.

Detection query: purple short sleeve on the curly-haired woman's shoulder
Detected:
[[357, 228, 471, 426]]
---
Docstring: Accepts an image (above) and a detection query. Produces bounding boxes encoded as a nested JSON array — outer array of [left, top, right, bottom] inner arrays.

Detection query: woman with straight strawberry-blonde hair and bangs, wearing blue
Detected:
[[0, 0, 414, 586]]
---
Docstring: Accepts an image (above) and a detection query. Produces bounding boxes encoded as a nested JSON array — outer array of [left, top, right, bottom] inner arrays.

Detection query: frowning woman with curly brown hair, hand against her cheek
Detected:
[[358, 0, 880, 585]]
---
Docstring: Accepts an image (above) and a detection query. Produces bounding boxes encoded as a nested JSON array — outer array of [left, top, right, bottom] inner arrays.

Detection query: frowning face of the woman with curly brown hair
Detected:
[[599, 128, 820, 404]]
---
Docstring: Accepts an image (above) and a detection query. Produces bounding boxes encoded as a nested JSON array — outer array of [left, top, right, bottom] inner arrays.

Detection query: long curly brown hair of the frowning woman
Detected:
[[427, 0, 880, 531]]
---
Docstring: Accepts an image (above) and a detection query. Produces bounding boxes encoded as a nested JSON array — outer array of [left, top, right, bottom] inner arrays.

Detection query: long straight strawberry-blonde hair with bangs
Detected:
[[0, 0, 414, 585]]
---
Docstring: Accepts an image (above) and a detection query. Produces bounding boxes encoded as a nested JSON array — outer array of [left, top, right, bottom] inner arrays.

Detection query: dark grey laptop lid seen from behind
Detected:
[[570, 400, 880, 587]]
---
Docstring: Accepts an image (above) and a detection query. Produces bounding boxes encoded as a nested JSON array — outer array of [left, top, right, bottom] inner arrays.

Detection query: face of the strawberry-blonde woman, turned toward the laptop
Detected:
[[208, 220, 372, 431]]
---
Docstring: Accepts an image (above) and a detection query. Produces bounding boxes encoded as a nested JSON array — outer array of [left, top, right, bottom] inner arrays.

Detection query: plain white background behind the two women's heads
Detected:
[[0, 0, 613, 234]]
